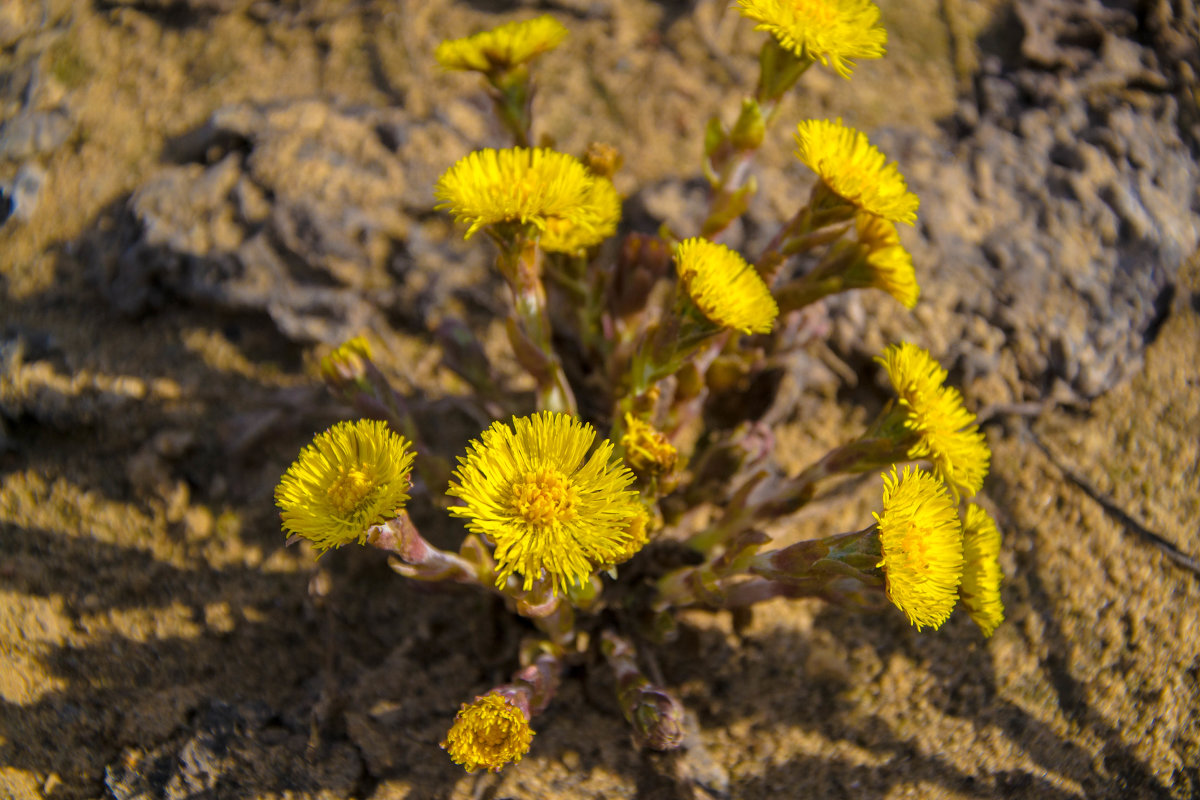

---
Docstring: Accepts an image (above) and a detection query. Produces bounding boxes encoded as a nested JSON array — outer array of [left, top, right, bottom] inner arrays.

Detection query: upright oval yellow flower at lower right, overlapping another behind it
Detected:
[[874, 467, 962, 631]]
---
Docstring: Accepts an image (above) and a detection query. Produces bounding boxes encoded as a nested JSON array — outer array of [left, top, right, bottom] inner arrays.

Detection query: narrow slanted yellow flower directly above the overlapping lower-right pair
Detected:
[[876, 342, 991, 497]]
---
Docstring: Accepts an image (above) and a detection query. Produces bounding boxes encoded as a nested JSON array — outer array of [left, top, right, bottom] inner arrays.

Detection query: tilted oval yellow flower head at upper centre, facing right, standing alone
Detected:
[[676, 237, 779, 333]]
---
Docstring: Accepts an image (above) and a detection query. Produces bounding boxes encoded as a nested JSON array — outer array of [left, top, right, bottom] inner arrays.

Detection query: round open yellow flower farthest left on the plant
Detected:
[[275, 420, 413, 552]]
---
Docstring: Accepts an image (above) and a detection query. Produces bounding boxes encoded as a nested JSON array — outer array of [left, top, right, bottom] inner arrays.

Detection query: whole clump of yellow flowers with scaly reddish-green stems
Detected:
[[276, 0, 1003, 771]]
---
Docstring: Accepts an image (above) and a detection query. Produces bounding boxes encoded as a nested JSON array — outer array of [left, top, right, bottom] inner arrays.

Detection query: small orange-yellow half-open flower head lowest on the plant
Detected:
[[442, 692, 534, 772]]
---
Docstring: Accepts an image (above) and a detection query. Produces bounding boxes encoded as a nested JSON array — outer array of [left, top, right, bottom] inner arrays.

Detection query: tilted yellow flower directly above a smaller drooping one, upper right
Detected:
[[796, 120, 920, 225]]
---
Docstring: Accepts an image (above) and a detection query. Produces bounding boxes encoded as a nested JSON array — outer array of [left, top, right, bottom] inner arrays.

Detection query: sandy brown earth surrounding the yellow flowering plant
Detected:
[[0, 0, 1200, 800]]
